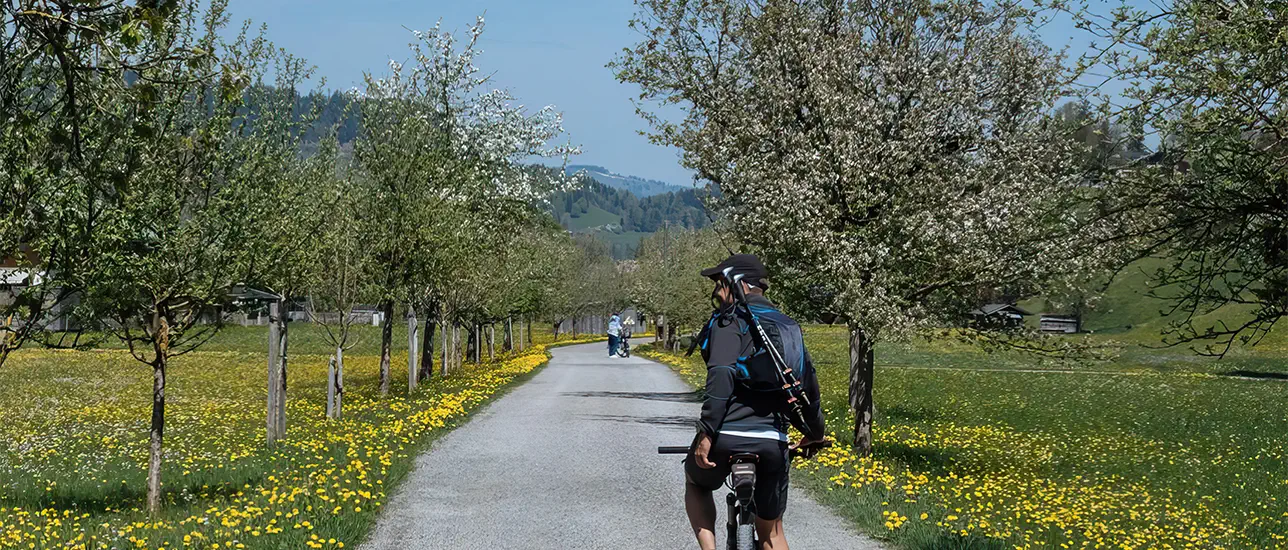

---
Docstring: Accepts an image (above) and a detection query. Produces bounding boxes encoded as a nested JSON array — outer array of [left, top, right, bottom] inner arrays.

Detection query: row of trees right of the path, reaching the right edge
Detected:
[[613, 0, 1288, 452]]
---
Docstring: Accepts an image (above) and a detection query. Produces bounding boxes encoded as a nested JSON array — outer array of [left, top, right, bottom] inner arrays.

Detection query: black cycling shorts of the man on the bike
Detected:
[[684, 434, 788, 520]]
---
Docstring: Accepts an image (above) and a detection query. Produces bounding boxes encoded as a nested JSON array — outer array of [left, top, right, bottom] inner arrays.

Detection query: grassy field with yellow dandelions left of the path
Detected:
[[0, 325, 597, 549]]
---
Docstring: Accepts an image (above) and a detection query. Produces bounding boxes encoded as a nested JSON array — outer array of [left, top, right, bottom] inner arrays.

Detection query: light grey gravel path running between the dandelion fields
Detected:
[[362, 344, 880, 550]]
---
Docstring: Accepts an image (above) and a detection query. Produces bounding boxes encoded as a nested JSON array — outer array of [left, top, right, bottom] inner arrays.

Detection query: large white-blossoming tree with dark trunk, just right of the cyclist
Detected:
[[613, 0, 1095, 453]]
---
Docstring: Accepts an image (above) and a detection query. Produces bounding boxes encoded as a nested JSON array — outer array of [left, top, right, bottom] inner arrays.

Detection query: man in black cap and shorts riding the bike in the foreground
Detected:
[[684, 254, 824, 550]]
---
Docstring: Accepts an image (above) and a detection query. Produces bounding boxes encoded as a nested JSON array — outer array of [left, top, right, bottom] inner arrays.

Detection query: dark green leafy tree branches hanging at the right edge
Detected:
[[1079, 0, 1288, 356]]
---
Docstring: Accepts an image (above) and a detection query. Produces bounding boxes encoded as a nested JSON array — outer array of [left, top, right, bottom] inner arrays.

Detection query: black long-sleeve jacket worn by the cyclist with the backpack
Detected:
[[698, 294, 826, 442]]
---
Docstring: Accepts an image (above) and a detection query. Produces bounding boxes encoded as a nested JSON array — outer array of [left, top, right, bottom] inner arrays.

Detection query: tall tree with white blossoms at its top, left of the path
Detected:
[[354, 17, 576, 392]]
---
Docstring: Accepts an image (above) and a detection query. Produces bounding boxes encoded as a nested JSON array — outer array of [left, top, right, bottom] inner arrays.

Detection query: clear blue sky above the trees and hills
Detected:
[[229, 0, 1128, 185]]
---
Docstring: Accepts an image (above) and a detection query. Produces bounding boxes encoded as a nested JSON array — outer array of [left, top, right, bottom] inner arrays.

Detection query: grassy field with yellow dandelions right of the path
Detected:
[[641, 326, 1288, 549]]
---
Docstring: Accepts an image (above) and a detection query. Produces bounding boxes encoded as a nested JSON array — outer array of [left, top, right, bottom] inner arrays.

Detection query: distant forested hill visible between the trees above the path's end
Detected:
[[550, 173, 710, 259]]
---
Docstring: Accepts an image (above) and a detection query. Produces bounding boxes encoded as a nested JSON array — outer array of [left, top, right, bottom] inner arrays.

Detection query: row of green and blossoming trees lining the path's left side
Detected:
[[0, 0, 598, 511]]
